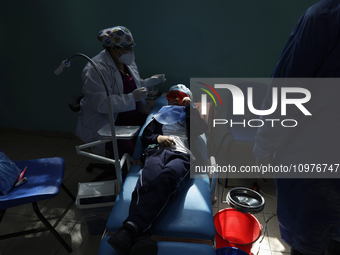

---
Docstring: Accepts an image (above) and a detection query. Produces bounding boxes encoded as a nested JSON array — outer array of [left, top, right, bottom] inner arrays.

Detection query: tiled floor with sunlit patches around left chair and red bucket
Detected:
[[0, 129, 289, 255]]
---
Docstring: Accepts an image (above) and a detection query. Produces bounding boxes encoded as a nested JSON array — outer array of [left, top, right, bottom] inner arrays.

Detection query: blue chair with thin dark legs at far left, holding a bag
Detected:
[[0, 157, 75, 253]]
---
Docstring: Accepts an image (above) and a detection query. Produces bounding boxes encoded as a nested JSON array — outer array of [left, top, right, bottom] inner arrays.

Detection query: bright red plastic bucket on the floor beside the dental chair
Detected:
[[214, 208, 262, 254]]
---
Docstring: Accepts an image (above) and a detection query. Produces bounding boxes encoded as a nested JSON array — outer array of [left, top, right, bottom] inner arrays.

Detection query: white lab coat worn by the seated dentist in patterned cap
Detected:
[[76, 50, 149, 155]]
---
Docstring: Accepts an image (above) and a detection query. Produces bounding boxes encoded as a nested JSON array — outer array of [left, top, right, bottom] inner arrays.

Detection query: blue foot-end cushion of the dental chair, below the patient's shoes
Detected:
[[98, 237, 215, 255]]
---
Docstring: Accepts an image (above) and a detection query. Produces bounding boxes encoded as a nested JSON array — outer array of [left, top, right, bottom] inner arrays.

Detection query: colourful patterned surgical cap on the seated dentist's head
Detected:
[[98, 26, 136, 48]]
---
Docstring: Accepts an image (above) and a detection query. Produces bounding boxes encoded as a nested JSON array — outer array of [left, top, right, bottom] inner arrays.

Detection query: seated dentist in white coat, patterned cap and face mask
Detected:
[[76, 26, 165, 157]]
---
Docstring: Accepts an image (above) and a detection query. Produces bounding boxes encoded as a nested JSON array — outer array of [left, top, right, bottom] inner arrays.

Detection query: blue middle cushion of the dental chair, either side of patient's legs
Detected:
[[106, 165, 215, 240]]
